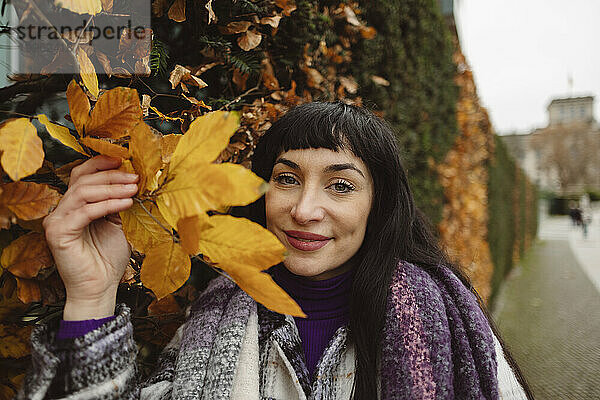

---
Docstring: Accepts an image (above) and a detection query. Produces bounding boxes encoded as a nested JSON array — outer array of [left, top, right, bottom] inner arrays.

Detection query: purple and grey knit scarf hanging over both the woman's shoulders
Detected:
[[172, 262, 498, 400]]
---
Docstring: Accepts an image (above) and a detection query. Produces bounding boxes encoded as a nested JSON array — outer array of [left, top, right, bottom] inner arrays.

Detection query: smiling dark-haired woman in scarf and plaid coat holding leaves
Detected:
[[20, 103, 526, 399]]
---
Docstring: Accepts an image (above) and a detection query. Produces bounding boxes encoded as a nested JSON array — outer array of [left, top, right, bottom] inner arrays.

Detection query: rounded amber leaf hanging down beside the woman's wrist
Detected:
[[140, 241, 191, 300]]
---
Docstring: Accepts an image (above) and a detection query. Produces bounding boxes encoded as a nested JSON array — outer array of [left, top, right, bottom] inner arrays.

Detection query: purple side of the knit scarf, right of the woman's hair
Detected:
[[381, 262, 498, 400]]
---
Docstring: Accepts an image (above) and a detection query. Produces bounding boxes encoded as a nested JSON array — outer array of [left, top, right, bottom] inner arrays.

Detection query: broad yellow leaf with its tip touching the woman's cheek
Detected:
[[158, 163, 268, 222]]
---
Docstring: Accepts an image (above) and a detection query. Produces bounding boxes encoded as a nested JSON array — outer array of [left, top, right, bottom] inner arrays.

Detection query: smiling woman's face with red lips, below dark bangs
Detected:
[[265, 148, 373, 279]]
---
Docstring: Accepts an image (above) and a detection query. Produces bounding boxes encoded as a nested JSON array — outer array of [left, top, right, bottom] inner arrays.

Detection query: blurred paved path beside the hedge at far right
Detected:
[[494, 208, 600, 400]]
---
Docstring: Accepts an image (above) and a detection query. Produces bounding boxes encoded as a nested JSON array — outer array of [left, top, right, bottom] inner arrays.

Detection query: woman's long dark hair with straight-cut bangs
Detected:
[[250, 102, 532, 399]]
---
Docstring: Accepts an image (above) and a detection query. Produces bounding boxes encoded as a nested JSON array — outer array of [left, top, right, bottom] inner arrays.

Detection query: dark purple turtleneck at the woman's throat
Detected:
[[269, 264, 354, 376]]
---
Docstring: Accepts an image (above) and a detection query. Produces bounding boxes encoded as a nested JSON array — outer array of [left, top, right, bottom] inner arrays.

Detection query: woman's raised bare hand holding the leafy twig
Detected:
[[43, 156, 138, 320]]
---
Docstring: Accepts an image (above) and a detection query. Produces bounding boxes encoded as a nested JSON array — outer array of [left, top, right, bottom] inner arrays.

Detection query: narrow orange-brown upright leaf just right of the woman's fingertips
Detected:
[[129, 121, 162, 194]]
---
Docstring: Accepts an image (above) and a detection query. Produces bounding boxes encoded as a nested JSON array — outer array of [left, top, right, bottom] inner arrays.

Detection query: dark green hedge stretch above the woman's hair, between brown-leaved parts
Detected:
[[353, 0, 458, 223]]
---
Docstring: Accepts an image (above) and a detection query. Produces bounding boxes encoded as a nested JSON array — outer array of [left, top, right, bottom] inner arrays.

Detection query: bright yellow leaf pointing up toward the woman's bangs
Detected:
[[169, 111, 239, 173]]
